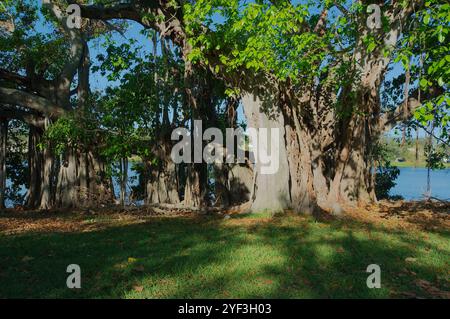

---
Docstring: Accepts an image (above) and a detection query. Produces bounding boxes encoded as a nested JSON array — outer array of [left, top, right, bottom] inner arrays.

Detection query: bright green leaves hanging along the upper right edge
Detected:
[[388, 0, 450, 145]]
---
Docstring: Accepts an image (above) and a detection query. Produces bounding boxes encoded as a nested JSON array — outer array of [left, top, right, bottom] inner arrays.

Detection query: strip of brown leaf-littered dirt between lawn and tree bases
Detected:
[[0, 201, 450, 235]]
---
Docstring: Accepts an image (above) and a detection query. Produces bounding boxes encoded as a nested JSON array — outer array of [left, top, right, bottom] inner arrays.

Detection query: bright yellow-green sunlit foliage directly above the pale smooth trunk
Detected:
[[185, 0, 327, 86]]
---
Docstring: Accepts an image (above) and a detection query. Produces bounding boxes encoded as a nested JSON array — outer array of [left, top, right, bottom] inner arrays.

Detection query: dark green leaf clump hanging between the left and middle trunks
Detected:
[[89, 38, 181, 159]]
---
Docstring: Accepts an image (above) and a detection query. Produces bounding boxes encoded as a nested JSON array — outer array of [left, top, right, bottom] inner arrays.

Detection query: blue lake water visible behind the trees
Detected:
[[6, 167, 450, 207]]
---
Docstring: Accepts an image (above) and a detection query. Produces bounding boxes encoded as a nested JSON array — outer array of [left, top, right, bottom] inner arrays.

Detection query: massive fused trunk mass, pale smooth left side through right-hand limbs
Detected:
[[236, 3, 412, 213]]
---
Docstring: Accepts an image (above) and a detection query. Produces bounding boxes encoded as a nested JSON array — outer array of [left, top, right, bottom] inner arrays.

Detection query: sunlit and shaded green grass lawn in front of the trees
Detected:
[[0, 214, 450, 298]]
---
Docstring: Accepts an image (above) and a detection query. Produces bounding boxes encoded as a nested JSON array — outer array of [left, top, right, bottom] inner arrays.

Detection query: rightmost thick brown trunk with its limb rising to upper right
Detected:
[[320, 20, 408, 211]]
